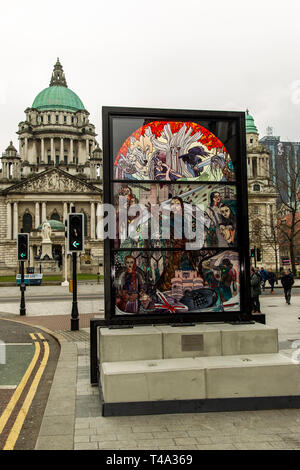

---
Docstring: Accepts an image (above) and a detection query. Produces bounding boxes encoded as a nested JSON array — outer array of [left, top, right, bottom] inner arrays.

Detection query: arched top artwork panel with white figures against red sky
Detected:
[[113, 121, 235, 182]]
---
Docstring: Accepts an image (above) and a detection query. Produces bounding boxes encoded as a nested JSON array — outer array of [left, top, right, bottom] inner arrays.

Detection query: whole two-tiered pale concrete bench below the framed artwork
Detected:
[[98, 323, 300, 414]]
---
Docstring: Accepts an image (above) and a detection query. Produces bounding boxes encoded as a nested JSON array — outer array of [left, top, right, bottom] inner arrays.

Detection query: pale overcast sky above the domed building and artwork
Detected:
[[0, 0, 300, 153]]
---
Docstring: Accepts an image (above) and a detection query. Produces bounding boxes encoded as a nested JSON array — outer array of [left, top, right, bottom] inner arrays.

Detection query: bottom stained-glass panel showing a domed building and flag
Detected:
[[112, 250, 240, 315]]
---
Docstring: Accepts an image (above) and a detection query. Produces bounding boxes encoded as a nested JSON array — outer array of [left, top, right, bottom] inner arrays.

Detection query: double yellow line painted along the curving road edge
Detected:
[[0, 333, 49, 450]]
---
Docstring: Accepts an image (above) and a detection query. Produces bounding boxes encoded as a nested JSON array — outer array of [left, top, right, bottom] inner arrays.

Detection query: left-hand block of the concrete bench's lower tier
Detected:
[[101, 358, 205, 403]]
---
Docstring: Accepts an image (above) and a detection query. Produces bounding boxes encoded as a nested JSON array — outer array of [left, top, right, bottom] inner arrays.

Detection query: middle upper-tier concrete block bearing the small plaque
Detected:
[[156, 324, 222, 359]]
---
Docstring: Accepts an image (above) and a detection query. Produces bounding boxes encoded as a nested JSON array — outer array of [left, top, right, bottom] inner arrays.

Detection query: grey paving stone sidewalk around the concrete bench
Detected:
[[36, 295, 300, 450]]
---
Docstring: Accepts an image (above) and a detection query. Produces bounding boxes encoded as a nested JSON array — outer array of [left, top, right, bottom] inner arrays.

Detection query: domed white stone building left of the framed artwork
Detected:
[[0, 59, 103, 274]]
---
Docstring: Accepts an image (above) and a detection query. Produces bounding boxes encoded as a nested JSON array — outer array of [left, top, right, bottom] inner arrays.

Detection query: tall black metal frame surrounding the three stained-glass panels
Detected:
[[102, 107, 253, 325]]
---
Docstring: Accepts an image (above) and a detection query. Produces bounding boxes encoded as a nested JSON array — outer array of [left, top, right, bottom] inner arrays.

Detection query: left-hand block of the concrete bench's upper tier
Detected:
[[98, 326, 163, 362]]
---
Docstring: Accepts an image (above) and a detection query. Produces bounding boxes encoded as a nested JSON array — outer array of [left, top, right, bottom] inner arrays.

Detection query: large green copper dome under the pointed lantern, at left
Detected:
[[32, 86, 84, 112]]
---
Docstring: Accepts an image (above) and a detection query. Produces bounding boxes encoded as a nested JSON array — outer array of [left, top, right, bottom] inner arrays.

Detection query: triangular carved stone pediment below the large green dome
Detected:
[[2, 168, 102, 195]]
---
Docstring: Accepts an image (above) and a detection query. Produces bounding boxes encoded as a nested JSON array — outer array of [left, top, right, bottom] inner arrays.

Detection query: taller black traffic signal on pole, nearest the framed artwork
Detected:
[[67, 207, 84, 331]]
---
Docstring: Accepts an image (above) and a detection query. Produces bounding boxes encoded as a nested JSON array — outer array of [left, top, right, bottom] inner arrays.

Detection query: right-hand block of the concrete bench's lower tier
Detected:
[[203, 354, 300, 398]]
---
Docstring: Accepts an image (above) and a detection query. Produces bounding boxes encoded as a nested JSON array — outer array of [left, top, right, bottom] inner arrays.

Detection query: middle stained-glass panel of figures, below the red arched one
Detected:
[[113, 183, 237, 249]]
